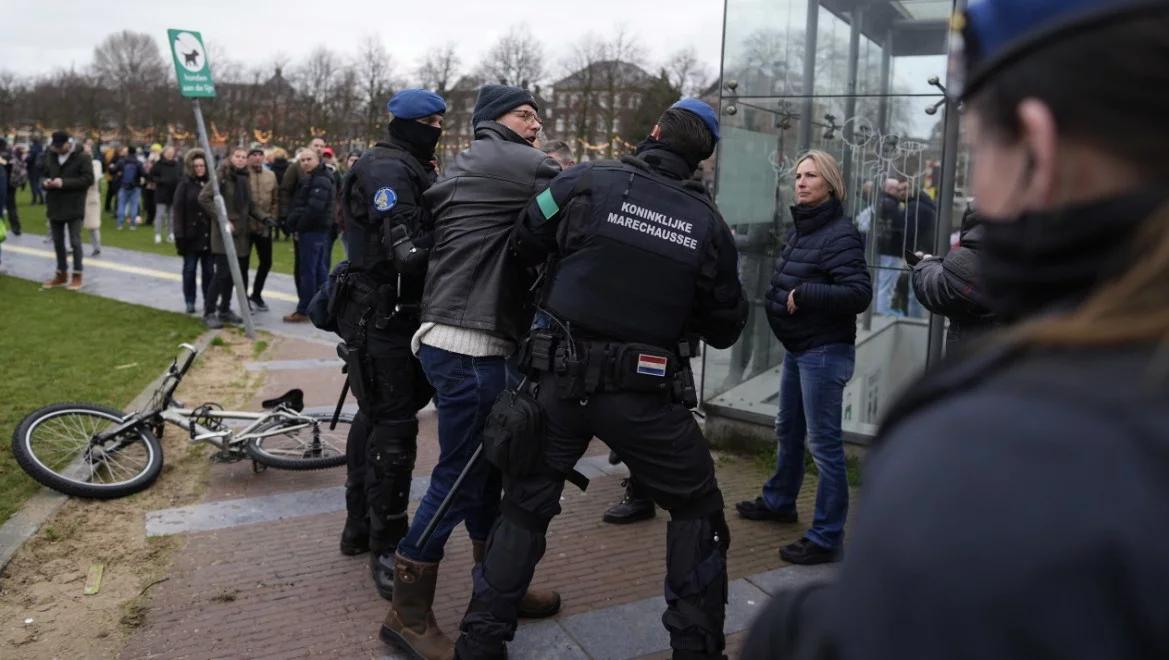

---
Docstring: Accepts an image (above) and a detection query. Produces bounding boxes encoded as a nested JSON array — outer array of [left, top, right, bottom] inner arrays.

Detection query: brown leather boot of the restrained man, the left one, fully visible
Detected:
[[380, 554, 455, 660]]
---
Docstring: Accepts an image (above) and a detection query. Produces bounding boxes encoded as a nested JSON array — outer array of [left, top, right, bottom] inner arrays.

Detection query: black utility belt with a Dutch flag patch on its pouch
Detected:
[[519, 331, 698, 408]]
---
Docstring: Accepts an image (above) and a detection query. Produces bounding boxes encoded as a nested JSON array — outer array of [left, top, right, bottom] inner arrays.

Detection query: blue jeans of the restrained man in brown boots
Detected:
[[397, 343, 514, 562]]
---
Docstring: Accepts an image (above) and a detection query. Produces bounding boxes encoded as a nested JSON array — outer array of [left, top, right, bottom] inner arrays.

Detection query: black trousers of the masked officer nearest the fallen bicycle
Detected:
[[338, 303, 434, 553]]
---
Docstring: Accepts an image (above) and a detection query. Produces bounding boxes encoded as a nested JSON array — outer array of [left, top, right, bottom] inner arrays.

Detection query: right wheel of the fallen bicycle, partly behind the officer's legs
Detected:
[[244, 412, 353, 470]]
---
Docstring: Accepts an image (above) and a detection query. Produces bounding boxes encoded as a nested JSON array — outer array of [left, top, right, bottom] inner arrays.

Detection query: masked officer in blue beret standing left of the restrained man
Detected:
[[334, 89, 447, 599]]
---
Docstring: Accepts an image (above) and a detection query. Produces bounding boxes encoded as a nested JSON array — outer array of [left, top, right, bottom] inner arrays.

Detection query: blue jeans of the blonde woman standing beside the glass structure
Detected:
[[763, 343, 857, 549]]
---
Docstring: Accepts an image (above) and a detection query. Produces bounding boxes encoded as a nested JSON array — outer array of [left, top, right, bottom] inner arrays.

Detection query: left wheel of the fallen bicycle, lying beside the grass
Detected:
[[12, 403, 162, 499]]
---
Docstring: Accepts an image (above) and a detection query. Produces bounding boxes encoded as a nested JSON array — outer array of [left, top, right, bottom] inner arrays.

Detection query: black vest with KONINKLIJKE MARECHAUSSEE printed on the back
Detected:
[[544, 162, 719, 350]]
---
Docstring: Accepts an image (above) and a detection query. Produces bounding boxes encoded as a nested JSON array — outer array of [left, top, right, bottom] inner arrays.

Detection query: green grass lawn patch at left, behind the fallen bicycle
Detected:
[[0, 278, 205, 523]]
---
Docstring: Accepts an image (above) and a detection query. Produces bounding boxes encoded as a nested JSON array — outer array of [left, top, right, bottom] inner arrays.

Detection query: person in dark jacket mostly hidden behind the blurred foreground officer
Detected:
[[913, 204, 995, 352]]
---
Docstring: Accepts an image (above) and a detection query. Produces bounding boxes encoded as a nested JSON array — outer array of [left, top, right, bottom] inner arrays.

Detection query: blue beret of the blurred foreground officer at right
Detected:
[[950, 0, 1169, 97]]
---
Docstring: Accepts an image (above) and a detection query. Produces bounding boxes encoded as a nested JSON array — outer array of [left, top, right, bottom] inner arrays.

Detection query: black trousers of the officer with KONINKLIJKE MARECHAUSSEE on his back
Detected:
[[457, 374, 731, 658]]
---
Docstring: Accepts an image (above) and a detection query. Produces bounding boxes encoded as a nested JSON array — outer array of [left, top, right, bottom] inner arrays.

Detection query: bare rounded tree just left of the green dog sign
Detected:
[[94, 30, 166, 128]]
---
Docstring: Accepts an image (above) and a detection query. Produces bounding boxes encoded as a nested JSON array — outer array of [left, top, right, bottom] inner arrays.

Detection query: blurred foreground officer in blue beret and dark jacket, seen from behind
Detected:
[[742, 0, 1169, 660]]
